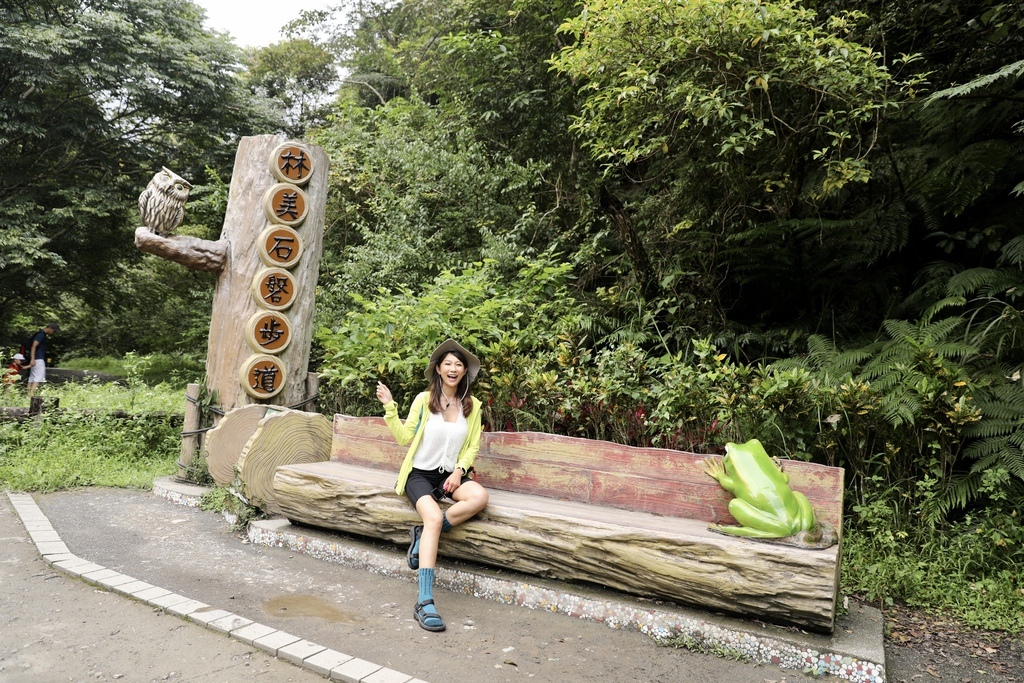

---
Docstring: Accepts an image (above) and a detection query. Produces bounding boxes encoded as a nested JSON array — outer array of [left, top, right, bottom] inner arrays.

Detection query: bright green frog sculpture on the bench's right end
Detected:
[[703, 439, 837, 548]]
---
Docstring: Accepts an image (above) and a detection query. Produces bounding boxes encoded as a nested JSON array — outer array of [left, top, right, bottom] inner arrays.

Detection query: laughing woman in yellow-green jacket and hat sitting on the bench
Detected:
[[377, 339, 487, 631]]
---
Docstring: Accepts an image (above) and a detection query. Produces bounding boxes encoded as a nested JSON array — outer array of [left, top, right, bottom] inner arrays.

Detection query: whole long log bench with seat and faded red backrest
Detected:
[[272, 415, 843, 632]]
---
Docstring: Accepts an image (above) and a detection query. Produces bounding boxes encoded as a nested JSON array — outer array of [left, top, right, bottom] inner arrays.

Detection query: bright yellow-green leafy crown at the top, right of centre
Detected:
[[554, 0, 895, 193]]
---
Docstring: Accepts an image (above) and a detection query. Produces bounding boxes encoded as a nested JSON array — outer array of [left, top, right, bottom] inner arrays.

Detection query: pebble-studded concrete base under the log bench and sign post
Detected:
[[154, 477, 886, 683]]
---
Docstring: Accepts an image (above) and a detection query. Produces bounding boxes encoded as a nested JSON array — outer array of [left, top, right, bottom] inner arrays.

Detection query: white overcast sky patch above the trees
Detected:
[[193, 0, 339, 47]]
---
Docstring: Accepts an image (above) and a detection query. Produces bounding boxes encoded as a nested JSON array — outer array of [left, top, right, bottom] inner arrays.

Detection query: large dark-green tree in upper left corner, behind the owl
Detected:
[[0, 0, 270, 344]]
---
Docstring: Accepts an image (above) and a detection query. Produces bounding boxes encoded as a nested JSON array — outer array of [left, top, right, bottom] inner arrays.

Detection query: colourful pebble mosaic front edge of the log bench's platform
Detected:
[[155, 479, 886, 683]]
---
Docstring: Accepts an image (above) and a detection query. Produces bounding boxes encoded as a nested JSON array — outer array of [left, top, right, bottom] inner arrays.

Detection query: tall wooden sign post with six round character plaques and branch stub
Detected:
[[135, 135, 330, 475]]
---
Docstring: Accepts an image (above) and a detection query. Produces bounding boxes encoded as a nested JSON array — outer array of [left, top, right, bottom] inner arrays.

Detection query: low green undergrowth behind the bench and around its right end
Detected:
[[321, 255, 1024, 631]]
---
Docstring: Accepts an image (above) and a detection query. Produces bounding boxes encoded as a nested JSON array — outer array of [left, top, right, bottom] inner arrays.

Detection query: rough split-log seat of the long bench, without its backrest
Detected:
[[273, 461, 840, 632]]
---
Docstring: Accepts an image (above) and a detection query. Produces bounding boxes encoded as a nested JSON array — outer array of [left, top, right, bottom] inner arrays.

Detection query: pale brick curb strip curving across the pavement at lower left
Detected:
[[7, 486, 425, 683]]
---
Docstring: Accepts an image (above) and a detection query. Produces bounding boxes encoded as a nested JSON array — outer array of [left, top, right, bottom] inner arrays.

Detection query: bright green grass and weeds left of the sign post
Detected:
[[0, 384, 184, 492]]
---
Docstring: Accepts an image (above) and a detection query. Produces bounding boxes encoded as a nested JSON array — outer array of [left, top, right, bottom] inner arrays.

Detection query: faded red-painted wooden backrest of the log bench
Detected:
[[331, 415, 844, 529]]
